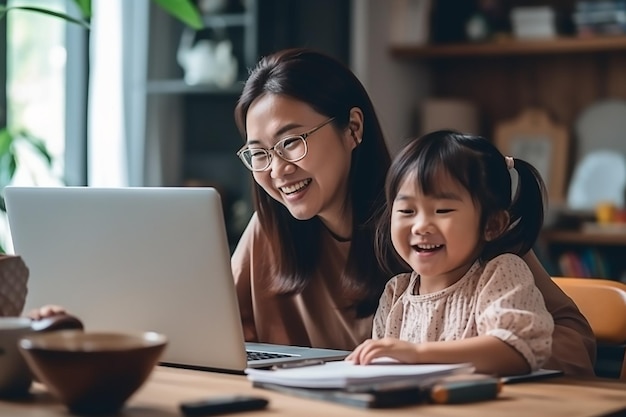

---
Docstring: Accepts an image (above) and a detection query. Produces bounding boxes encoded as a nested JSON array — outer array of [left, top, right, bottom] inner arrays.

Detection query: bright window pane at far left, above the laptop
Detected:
[[6, 0, 67, 185]]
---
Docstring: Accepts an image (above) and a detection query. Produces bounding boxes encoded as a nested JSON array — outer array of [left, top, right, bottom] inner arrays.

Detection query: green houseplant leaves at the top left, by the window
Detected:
[[0, 0, 203, 253]]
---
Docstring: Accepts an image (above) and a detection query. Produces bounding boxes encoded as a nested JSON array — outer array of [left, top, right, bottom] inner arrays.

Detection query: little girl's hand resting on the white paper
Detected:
[[346, 337, 420, 365]]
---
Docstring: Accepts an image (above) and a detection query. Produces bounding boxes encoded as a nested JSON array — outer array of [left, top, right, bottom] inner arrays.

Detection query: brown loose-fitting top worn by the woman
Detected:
[[231, 214, 595, 375]]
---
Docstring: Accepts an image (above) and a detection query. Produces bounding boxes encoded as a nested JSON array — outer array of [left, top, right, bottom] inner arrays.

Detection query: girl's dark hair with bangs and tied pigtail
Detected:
[[376, 130, 546, 265]]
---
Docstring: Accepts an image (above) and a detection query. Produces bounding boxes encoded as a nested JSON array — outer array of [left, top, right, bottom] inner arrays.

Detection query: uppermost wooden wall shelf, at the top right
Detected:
[[390, 36, 626, 58]]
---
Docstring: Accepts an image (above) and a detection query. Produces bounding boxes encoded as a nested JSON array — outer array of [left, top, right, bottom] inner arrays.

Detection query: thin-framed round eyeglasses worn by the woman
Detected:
[[237, 117, 335, 172]]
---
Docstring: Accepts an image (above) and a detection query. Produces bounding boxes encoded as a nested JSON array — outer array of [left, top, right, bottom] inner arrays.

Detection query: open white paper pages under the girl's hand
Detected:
[[246, 361, 474, 388]]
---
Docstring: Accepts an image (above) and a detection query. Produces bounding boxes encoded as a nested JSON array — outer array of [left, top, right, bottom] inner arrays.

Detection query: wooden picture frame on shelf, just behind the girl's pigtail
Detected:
[[494, 108, 569, 203]]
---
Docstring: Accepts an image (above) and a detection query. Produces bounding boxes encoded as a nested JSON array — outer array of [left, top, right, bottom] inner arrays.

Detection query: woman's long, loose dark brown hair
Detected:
[[235, 48, 390, 317]]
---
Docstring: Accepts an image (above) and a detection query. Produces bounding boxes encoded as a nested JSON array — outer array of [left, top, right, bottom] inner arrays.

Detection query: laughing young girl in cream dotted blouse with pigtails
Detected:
[[348, 131, 554, 375]]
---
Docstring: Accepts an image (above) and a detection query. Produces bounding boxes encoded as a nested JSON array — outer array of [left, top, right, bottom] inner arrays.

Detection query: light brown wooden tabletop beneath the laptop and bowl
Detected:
[[0, 367, 626, 417]]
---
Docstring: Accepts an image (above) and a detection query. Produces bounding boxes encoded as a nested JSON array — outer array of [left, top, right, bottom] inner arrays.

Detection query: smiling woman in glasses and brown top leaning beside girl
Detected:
[[231, 49, 595, 375]]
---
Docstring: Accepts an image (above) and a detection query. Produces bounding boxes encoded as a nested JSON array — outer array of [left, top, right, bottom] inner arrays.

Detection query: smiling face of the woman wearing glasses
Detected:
[[246, 94, 355, 226]]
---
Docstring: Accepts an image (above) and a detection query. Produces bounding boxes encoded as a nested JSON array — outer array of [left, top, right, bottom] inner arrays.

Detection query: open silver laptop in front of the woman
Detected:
[[5, 186, 349, 372]]
